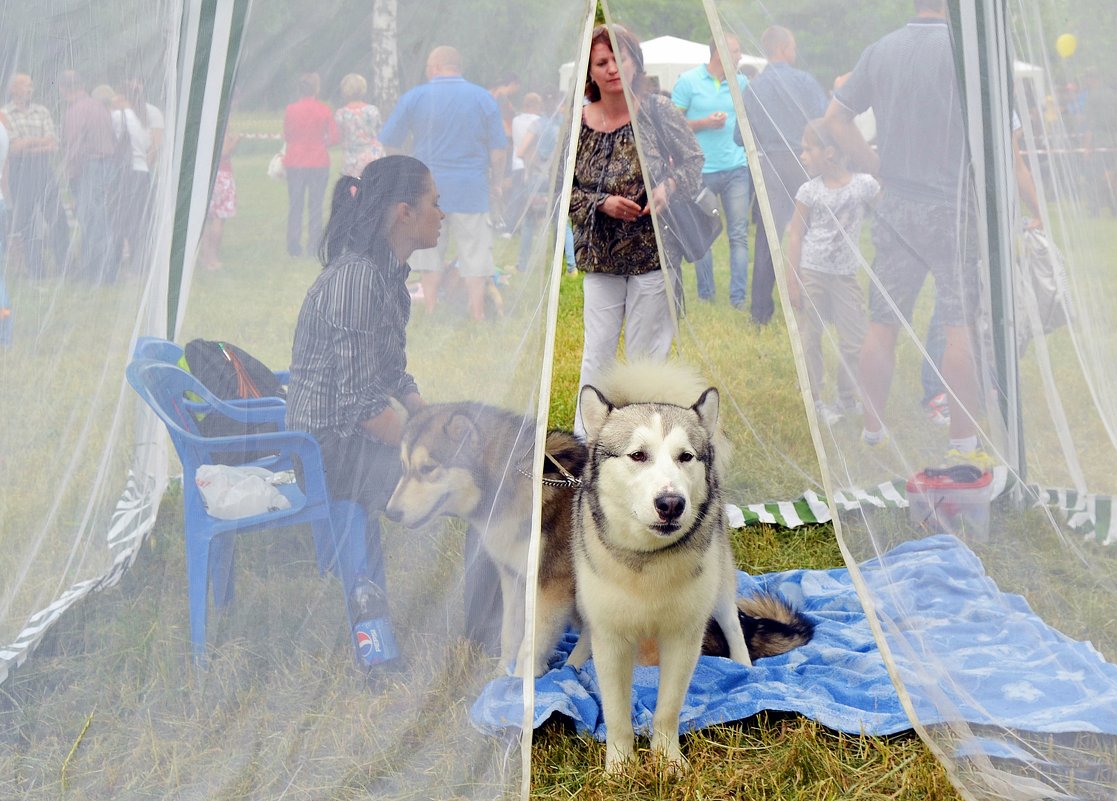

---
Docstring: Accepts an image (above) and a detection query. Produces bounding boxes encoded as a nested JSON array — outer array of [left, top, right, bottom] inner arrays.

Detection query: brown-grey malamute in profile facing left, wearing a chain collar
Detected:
[[386, 401, 586, 676]]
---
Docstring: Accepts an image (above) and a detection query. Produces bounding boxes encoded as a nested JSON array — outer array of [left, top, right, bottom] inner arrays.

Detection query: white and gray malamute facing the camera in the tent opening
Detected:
[[572, 362, 813, 772]]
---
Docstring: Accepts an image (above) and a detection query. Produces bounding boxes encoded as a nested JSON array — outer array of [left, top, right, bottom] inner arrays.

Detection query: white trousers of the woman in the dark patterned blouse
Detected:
[[574, 270, 675, 439]]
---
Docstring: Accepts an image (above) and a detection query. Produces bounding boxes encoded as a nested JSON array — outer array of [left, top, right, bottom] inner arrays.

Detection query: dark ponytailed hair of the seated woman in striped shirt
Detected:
[[318, 155, 431, 267]]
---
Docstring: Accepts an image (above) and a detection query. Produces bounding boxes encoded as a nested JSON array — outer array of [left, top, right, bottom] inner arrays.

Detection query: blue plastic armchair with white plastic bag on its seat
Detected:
[[127, 359, 373, 659]]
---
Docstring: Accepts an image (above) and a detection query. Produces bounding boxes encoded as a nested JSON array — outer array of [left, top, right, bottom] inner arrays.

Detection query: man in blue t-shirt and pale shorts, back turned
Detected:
[[380, 45, 507, 321]]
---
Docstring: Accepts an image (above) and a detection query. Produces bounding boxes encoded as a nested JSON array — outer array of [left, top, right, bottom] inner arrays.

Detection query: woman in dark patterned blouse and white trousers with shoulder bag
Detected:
[[570, 26, 704, 436]]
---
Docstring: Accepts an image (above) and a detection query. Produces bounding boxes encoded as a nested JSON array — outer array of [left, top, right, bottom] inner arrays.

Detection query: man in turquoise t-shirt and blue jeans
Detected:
[[671, 36, 752, 308]]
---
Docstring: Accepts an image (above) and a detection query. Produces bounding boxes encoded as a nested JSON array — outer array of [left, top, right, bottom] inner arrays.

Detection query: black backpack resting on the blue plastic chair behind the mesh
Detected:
[[180, 340, 287, 465]]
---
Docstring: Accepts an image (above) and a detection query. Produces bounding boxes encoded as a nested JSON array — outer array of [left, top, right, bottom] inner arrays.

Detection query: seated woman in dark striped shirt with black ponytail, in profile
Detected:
[[287, 155, 445, 603]]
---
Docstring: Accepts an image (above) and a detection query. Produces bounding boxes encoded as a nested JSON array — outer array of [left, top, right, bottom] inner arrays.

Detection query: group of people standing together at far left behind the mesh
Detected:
[[0, 69, 163, 285]]
